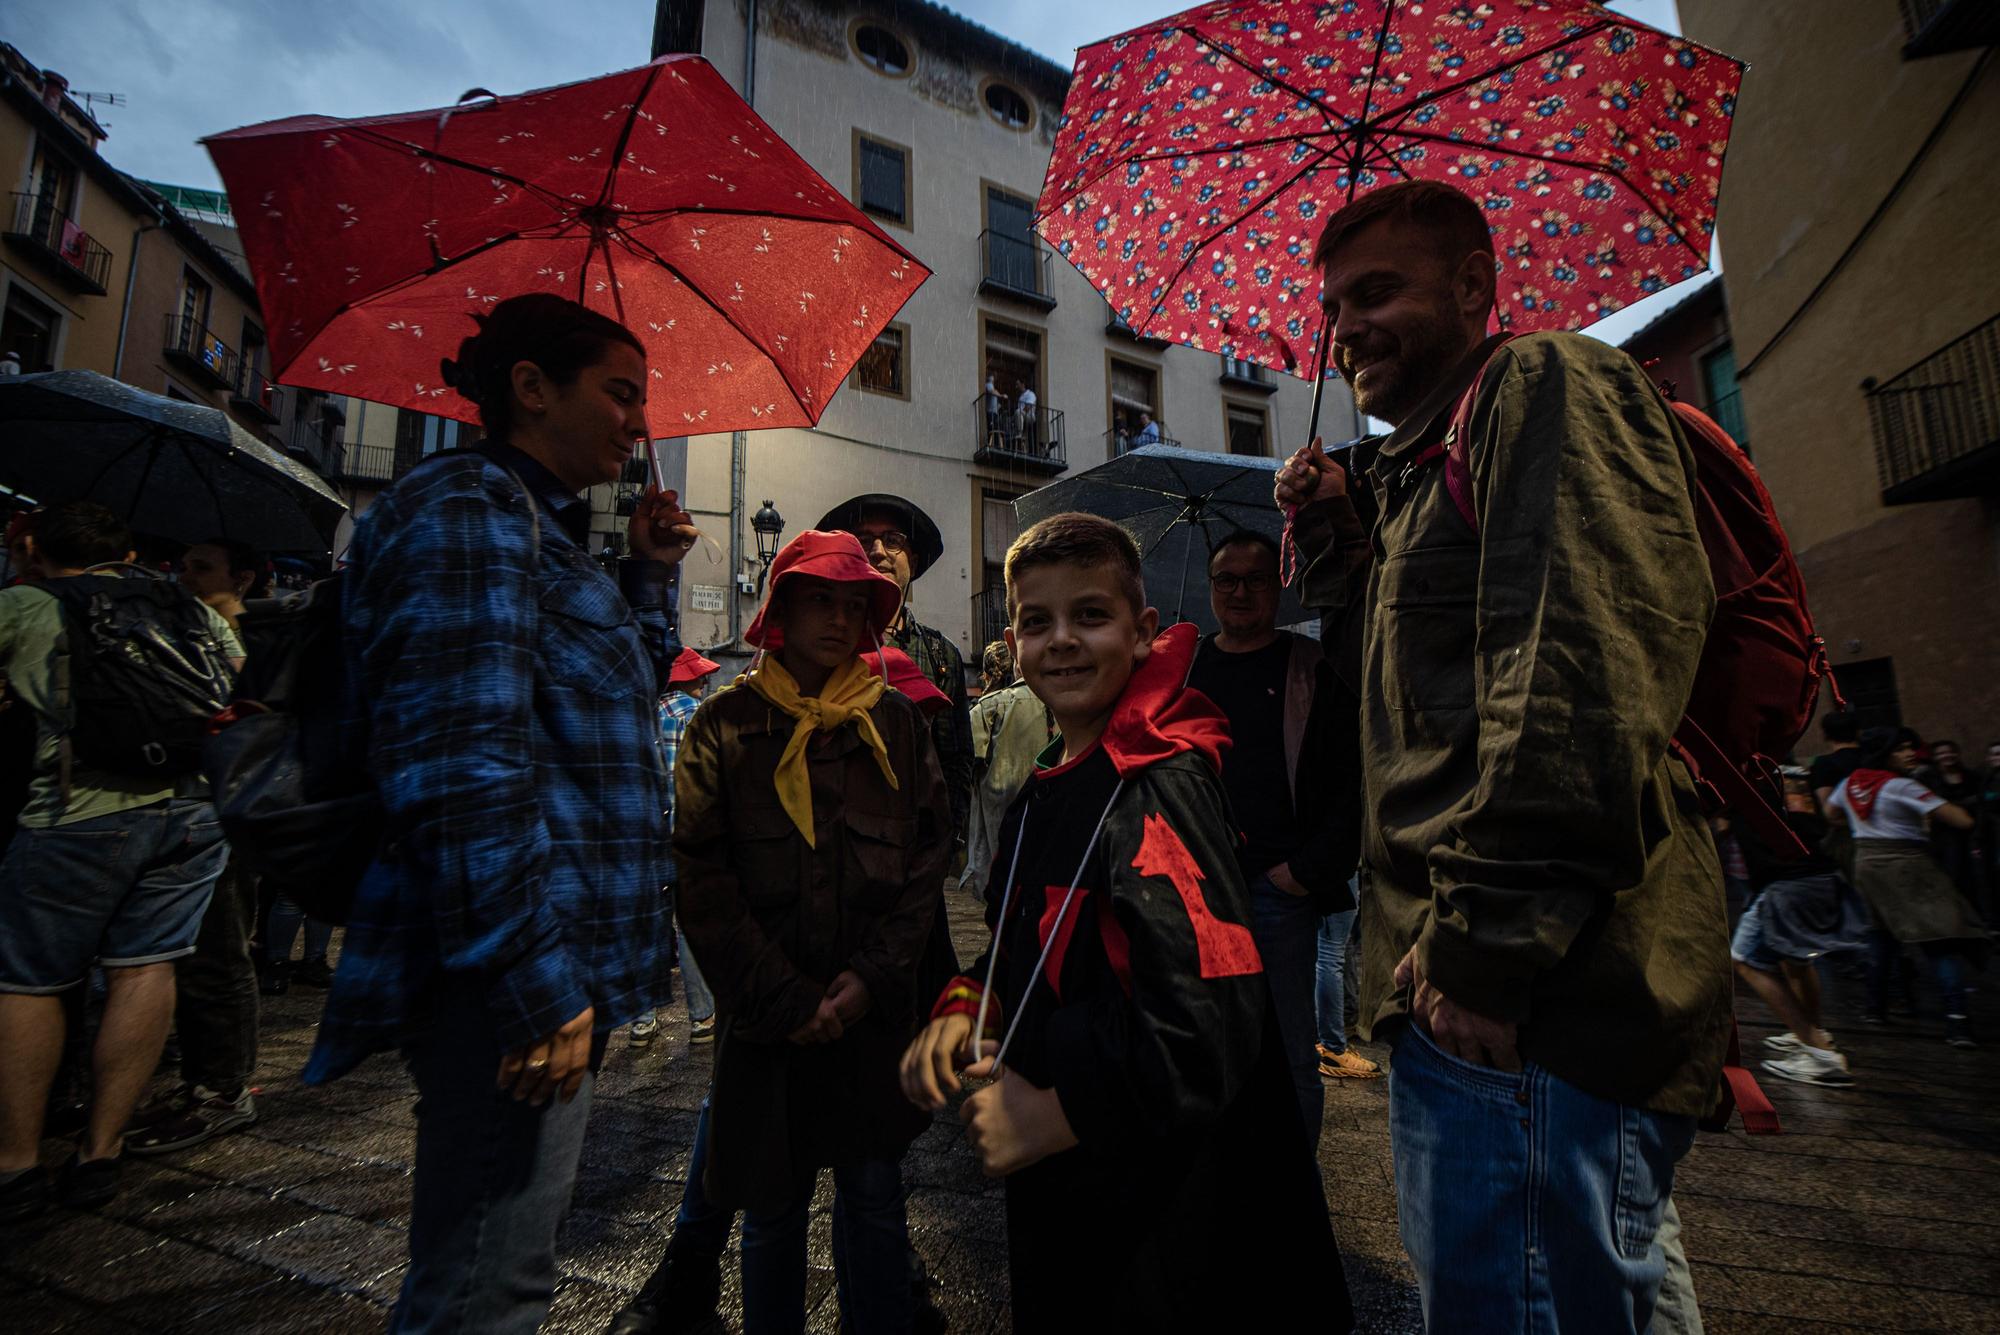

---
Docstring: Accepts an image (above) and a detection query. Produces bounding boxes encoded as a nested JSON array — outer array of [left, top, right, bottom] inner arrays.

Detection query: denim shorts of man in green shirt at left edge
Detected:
[[0, 797, 230, 993]]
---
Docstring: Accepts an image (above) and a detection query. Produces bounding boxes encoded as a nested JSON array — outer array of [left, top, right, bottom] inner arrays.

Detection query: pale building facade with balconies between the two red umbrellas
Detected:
[[654, 0, 1358, 662]]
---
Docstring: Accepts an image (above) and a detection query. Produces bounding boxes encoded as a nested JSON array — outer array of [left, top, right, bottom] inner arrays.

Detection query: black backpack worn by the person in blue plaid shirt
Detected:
[[202, 574, 382, 923]]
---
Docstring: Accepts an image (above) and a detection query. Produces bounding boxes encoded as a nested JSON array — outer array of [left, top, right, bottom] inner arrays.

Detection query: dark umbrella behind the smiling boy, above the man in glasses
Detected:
[[1014, 446, 1344, 634]]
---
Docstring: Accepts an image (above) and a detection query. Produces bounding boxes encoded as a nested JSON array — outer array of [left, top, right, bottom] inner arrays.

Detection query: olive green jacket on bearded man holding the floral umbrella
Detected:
[[1298, 334, 1730, 1115]]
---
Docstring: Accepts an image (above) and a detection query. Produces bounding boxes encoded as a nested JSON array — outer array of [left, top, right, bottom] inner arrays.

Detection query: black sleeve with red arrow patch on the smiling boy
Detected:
[[1048, 767, 1264, 1145]]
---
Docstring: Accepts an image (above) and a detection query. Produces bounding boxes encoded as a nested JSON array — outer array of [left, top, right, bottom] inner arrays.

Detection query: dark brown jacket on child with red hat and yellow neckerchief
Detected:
[[674, 685, 952, 1209]]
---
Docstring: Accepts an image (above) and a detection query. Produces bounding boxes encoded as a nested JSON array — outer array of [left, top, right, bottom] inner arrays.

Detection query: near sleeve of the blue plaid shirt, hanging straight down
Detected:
[[356, 484, 590, 1049]]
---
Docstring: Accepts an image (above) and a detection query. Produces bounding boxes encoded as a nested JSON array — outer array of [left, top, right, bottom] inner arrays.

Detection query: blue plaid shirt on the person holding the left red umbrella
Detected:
[[306, 444, 680, 1083]]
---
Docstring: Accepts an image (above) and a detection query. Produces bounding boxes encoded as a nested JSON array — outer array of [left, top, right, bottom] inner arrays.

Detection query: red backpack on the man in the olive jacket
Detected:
[[1414, 346, 1846, 1133]]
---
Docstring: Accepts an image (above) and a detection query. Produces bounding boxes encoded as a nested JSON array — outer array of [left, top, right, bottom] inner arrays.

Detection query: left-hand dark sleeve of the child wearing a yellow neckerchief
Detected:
[[674, 697, 832, 1043]]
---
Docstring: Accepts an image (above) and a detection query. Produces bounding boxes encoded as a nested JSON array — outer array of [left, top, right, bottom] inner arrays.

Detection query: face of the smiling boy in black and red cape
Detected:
[[1006, 564, 1160, 759]]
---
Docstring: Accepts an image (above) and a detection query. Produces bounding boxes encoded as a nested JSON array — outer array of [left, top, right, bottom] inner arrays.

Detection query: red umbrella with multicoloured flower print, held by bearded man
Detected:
[[1036, 0, 1742, 421]]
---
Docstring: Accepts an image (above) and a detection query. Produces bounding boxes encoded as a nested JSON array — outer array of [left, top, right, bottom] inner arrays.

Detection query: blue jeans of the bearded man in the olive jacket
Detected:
[[1388, 1023, 1694, 1335]]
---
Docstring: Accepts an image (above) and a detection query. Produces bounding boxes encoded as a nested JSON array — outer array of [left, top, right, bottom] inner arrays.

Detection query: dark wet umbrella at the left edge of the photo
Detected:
[[0, 372, 346, 556]]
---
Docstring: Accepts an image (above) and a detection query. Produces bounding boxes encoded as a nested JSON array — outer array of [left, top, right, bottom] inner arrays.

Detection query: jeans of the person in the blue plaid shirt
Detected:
[[390, 979, 596, 1335]]
